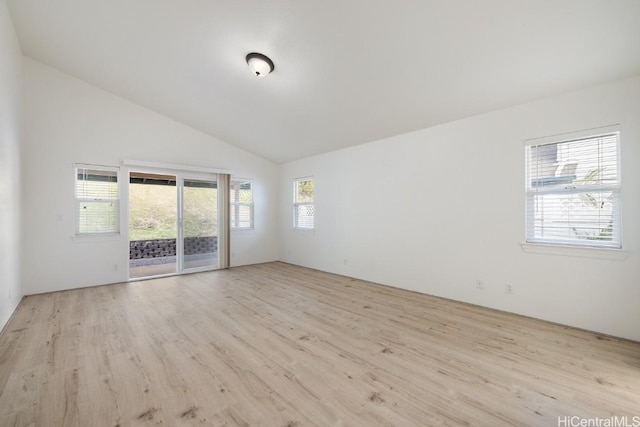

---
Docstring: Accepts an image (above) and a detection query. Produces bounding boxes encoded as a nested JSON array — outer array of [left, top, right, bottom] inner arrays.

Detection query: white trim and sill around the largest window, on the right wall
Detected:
[[521, 124, 627, 251]]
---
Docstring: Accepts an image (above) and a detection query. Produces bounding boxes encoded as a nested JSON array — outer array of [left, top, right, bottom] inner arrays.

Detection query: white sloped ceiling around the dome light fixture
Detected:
[[7, 0, 640, 162]]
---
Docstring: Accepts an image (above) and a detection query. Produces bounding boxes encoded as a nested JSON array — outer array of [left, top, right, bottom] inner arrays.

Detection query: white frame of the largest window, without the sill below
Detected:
[[525, 125, 622, 250]]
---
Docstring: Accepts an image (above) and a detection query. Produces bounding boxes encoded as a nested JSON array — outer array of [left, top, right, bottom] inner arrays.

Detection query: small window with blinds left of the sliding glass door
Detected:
[[75, 165, 120, 236]]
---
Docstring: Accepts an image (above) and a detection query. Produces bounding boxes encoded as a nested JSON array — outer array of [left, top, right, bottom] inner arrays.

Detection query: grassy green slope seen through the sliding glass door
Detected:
[[129, 184, 218, 240]]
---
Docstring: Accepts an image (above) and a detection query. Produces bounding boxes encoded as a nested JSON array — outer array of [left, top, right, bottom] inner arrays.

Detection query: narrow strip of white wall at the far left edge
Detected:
[[0, 0, 23, 329]]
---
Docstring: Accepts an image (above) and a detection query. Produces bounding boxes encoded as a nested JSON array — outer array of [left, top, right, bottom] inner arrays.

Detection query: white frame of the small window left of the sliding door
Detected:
[[73, 163, 122, 239]]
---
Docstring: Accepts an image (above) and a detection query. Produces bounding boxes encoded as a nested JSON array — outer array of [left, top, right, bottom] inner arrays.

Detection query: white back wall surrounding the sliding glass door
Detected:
[[22, 59, 278, 294]]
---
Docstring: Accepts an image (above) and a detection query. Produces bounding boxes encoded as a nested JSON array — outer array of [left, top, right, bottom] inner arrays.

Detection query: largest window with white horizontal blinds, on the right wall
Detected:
[[526, 129, 621, 248]]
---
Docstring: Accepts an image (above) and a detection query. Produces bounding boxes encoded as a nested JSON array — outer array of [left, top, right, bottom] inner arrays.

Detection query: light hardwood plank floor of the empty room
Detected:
[[0, 263, 640, 427]]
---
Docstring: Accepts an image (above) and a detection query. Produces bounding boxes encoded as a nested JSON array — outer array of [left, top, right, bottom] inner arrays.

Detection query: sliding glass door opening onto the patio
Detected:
[[129, 171, 223, 279]]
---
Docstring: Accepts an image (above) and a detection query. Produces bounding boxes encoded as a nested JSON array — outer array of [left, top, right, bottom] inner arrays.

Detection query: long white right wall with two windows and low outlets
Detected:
[[280, 78, 640, 340]]
